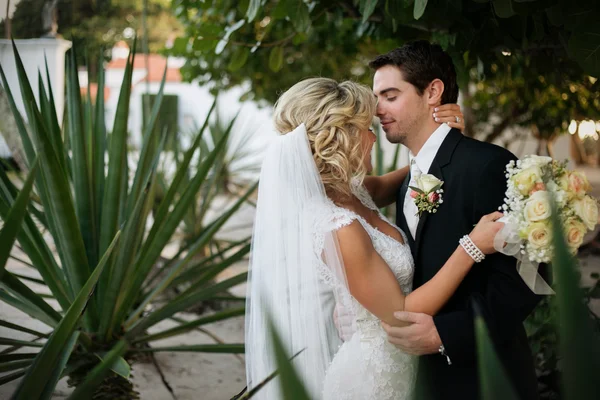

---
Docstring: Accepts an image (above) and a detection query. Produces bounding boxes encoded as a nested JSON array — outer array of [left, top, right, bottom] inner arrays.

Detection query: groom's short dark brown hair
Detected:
[[369, 40, 458, 104]]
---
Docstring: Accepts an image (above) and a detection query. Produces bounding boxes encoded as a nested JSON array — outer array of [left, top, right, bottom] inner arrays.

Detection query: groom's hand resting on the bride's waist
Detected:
[[382, 311, 442, 356]]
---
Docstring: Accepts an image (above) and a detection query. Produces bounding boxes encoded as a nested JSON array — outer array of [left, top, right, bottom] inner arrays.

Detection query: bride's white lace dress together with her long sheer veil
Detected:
[[245, 124, 417, 400]]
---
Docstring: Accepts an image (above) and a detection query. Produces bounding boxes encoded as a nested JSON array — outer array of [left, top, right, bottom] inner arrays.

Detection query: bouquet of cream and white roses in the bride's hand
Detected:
[[496, 155, 598, 289]]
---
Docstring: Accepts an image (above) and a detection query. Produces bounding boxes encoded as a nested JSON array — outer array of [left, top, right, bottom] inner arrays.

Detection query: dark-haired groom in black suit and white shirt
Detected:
[[369, 41, 540, 400]]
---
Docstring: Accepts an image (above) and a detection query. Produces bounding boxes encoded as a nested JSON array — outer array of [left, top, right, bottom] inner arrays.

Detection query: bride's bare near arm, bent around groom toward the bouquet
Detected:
[[337, 213, 503, 326]]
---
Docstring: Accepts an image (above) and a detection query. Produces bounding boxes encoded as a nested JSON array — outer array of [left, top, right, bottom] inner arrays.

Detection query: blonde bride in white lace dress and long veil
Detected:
[[246, 78, 503, 400]]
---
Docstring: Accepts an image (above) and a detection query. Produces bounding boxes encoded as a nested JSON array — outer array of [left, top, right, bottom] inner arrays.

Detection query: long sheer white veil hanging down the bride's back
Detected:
[[245, 124, 355, 400]]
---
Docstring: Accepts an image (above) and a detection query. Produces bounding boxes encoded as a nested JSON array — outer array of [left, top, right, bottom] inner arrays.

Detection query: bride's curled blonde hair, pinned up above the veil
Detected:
[[274, 78, 376, 198]]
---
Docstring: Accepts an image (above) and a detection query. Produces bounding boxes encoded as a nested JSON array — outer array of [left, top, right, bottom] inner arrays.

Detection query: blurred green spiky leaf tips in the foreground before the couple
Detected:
[[255, 188, 600, 400]]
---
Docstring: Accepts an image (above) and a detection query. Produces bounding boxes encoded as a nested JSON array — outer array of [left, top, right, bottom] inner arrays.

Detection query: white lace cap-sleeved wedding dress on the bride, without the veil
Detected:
[[315, 184, 417, 400]]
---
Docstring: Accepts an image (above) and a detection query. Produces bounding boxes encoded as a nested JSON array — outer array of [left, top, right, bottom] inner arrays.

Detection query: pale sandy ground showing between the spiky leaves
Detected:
[[0, 168, 600, 400]]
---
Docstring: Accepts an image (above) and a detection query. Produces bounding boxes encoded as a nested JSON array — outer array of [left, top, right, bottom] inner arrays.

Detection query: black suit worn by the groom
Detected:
[[396, 129, 540, 400]]
